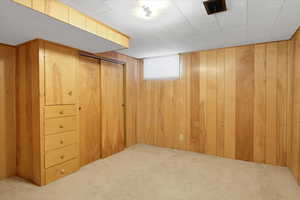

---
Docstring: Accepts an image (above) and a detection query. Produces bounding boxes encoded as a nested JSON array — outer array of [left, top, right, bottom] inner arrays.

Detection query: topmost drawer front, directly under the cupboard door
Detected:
[[45, 105, 76, 119]]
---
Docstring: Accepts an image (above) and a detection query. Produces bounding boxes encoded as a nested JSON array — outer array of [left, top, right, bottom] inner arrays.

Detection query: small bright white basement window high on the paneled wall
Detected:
[[144, 55, 180, 80]]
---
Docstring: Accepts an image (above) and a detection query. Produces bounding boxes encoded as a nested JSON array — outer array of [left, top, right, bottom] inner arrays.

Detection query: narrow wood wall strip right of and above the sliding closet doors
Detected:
[[99, 52, 140, 147]]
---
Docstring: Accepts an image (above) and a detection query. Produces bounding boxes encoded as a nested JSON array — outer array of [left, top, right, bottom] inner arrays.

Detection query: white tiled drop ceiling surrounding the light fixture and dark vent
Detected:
[[60, 0, 300, 58]]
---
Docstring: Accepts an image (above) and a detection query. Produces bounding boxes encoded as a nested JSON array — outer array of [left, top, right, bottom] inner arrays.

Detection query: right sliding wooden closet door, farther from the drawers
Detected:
[[101, 61, 125, 157]]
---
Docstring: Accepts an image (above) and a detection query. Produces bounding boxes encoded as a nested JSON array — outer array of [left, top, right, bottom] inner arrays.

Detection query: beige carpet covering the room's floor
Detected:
[[0, 145, 300, 200]]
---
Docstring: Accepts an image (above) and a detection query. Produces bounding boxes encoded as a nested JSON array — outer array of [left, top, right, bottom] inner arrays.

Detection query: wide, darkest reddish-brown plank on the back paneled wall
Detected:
[[236, 45, 254, 161]]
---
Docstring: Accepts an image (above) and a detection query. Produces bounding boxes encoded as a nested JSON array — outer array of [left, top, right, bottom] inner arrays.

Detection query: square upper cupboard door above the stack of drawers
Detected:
[[45, 42, 78, 105]]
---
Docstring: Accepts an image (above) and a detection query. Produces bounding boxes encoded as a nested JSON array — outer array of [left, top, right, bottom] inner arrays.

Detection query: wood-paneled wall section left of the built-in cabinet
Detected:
[[0, 44, 16, 179]]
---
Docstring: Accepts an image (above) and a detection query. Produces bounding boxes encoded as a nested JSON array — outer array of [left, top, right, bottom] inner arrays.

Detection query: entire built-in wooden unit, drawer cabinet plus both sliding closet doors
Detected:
[[16, 40, 126, 185]]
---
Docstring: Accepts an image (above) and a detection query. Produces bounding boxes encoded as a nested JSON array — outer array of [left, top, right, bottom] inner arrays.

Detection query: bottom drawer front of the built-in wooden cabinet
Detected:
[[45, 144, 78, 168]]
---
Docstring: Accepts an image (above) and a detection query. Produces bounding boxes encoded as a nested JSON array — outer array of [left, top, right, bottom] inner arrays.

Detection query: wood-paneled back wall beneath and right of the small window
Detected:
[[137, 41, 300, 166]]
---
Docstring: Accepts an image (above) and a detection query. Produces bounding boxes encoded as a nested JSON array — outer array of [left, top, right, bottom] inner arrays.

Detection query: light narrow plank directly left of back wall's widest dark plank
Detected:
[[224, 48, 236, 158]]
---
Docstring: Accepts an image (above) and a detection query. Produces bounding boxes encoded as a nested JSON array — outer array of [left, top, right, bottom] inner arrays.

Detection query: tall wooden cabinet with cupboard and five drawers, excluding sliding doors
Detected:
[[16, 40, 79, 185]]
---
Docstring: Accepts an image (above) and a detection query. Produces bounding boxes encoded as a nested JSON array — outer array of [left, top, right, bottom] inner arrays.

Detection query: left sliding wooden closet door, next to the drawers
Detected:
[[78, 57, 101, 166]]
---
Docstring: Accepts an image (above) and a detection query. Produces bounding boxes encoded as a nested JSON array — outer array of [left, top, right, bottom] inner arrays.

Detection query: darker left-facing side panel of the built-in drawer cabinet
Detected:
[[16, 40, 44, 185]]
